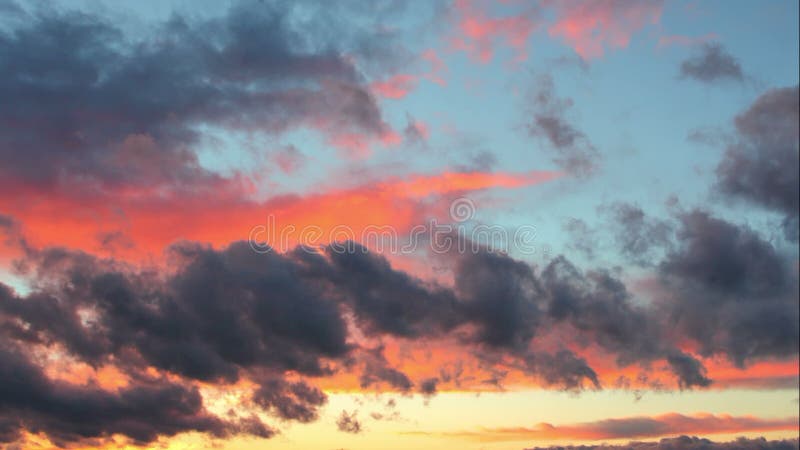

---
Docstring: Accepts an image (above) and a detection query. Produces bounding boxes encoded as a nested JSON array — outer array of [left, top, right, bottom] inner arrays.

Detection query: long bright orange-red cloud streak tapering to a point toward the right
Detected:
[[0, 172, 560, 264]]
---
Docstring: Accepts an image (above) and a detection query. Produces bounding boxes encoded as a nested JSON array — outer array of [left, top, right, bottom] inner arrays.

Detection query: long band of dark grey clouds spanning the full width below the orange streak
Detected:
[[0, 223, 798, 442]]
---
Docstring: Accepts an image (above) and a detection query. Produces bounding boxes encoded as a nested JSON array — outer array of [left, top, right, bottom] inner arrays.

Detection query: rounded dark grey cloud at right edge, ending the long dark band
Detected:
[[658, 211, 800, 366]]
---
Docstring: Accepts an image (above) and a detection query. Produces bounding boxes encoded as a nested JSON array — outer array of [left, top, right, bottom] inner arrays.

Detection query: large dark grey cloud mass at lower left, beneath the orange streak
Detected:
[[0, 243, 350, 443]]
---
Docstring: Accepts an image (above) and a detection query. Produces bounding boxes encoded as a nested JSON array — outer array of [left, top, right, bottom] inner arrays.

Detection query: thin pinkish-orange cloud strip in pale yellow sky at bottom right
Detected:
[[434, 413, 797, 442]]
